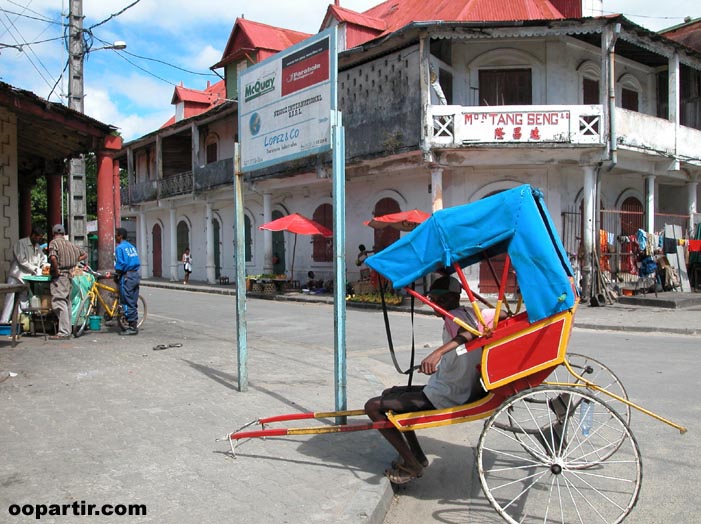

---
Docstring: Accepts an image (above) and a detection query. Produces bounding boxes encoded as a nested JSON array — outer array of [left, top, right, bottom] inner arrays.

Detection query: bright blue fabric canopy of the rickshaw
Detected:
[[365, 185, 575, 322]]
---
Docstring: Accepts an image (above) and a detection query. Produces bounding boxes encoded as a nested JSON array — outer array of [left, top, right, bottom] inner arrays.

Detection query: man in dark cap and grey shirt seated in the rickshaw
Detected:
[[365, 276, 506, 484]]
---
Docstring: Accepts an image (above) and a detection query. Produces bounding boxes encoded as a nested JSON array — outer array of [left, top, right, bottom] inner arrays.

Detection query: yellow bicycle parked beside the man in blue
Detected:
[[73, 266, 147, 337]]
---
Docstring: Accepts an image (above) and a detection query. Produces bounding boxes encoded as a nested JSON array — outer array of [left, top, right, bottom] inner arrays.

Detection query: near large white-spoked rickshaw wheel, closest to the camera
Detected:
[[476, 386, 642, 524]]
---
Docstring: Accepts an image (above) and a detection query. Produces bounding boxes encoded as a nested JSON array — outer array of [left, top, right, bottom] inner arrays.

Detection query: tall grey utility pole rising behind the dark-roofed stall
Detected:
[[67, 0, 87, 247]]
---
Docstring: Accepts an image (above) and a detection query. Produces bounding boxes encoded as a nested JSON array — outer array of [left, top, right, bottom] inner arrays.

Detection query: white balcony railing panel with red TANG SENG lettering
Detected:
[[428, 105, 604, 147]]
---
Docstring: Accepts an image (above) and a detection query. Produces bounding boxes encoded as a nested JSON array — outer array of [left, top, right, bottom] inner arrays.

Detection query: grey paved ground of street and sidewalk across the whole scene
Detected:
[[0, 284, 700, 524]]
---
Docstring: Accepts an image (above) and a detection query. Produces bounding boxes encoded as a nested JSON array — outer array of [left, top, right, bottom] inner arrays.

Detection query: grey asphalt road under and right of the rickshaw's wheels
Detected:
[[385, 329, 701, 524]]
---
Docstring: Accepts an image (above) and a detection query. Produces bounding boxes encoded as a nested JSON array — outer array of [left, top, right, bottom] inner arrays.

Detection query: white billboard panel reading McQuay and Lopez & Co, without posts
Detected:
[[238, 28, 338, 172]]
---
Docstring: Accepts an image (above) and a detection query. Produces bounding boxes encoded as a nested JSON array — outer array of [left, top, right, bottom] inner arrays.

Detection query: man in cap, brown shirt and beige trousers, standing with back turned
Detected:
[[49, 224, 88, 340]]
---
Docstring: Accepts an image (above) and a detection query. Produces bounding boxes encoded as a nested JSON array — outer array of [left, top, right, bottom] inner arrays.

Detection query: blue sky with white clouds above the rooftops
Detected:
[[0, 0, 701, 141]]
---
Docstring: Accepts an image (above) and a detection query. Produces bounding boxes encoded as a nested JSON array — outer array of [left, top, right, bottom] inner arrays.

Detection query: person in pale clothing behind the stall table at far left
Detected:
[[0, 228, 46, 324]]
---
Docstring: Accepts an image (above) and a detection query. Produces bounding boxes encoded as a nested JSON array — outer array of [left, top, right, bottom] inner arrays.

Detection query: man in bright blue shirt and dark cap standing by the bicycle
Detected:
[[114, 227, 141, 335]]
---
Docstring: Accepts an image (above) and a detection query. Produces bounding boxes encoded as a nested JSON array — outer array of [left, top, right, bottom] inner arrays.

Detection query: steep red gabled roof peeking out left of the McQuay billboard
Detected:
[[211, 18, 312, 69]]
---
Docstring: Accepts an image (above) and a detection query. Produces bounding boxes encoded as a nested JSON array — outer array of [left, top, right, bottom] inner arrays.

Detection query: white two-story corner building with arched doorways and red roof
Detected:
[[117, 0, 701, 294]]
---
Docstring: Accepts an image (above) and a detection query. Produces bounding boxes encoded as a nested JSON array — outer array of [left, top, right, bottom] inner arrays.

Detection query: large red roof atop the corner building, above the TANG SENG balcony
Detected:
[[363, 0, 564, 32]]
